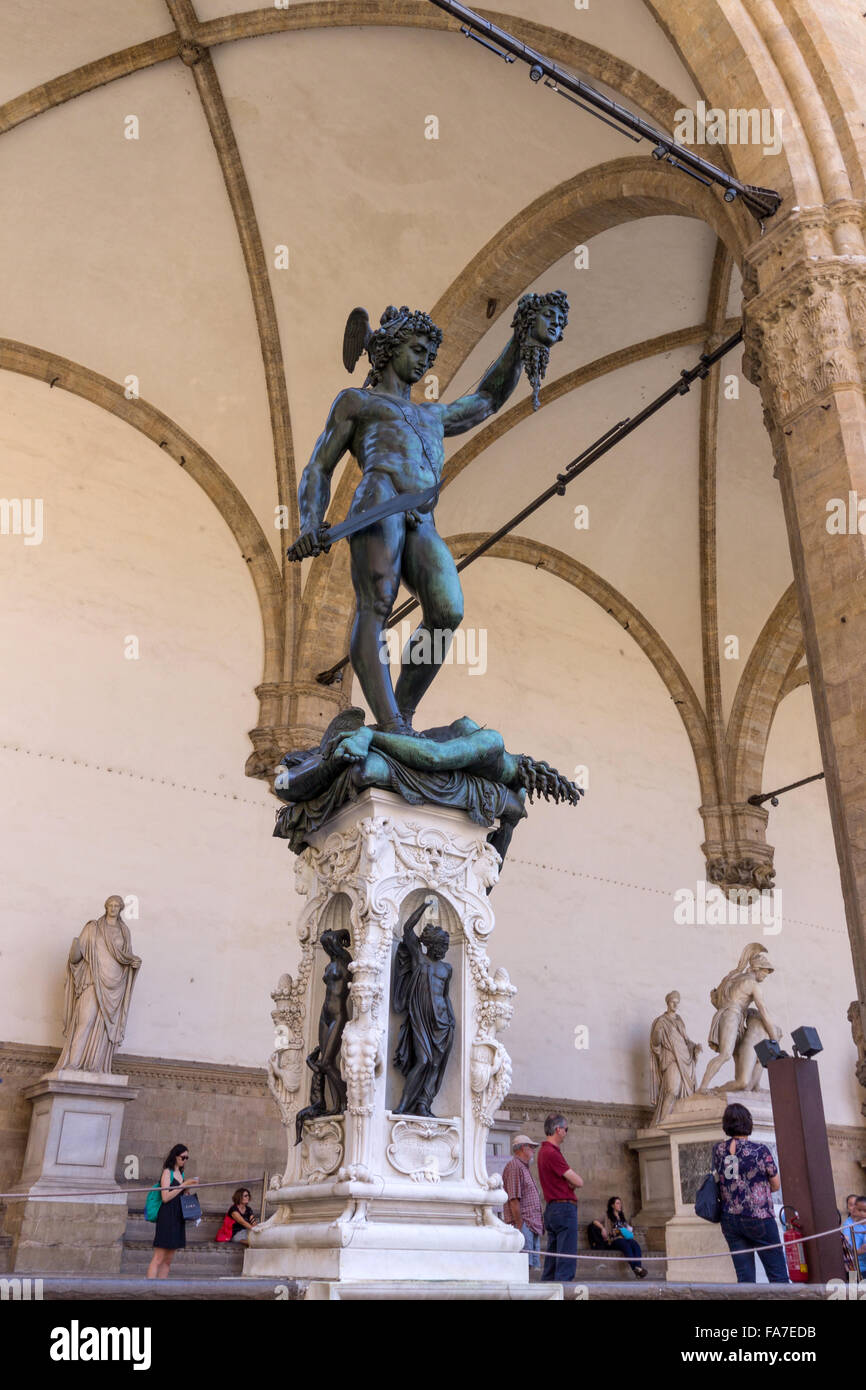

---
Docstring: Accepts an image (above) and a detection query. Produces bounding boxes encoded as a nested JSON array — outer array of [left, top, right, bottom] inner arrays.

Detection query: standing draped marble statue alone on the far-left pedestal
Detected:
[[57, 897, 142, 1072]]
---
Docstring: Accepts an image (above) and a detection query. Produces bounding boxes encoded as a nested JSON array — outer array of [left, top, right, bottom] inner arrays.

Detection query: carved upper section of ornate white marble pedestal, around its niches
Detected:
[[268, 794, 516, 1190]]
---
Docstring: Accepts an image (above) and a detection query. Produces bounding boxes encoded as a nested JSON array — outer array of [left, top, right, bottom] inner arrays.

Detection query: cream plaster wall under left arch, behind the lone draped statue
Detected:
[[0, 373, 293, 1065]]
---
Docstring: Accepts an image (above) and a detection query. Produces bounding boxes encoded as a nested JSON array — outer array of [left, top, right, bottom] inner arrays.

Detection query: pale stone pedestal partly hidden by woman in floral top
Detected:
[[630, 1090, 776, 1284]]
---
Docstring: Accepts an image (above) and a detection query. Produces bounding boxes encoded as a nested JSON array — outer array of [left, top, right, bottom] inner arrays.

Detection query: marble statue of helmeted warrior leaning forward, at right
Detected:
[[701, 941, 781, 1091]]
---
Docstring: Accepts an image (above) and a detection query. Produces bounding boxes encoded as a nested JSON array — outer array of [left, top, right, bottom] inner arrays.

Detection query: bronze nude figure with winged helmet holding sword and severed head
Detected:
[[288, 291, 569, 734]]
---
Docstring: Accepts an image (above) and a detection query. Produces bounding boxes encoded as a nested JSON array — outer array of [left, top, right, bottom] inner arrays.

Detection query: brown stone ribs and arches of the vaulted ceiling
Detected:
[[0, 0, 845, 889]]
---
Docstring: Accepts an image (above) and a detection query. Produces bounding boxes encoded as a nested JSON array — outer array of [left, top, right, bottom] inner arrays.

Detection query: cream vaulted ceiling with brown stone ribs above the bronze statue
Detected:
[[0, 0, 799, 822]]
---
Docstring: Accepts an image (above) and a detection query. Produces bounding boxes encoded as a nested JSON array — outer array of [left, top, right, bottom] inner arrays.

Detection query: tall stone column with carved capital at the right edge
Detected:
[[744, 202, 866, 1100]]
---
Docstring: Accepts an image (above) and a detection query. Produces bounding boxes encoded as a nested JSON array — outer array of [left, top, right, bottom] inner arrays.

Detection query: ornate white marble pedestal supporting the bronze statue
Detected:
[[243, 788, 530, 1298]]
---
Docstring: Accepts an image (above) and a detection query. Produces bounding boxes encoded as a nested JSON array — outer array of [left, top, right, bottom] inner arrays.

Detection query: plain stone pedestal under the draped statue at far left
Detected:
[[6, 1069, 138, 1275]]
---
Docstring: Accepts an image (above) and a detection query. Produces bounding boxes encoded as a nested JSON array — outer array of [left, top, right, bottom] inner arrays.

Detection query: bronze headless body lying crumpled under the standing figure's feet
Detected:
[[274, 708, 581, 859]]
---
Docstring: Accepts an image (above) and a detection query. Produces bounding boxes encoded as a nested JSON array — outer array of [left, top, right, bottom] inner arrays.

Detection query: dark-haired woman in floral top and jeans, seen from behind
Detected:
[[713, 1105, 788, 1284]]
